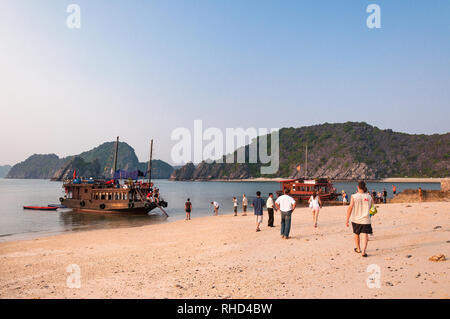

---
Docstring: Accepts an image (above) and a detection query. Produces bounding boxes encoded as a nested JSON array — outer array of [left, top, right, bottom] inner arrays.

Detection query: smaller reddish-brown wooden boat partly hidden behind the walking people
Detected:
[[277, 178, 339, 202]]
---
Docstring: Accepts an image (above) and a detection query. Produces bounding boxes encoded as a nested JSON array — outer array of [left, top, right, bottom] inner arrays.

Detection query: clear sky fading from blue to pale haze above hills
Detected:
[[0, 0, 450, 165]]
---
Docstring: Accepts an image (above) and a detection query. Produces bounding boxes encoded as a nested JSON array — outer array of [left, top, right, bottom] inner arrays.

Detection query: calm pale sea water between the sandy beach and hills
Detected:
[[0, 178, 440, 241]]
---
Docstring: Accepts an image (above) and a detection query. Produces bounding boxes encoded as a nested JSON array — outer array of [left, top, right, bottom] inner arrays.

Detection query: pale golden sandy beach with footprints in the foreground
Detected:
[[0, 202, 450, 298]]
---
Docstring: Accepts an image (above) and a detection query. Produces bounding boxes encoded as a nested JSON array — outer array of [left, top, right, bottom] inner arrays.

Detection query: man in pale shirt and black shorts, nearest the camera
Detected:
[[345, 181, 373, 257]]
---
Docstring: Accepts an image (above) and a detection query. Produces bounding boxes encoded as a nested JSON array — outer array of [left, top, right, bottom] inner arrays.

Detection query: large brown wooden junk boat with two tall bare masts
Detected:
[[59, 137, 167, 216]]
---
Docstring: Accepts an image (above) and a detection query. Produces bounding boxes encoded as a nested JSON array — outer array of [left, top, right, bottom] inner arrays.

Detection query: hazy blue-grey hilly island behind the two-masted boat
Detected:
[[6, 142, 174, 180]]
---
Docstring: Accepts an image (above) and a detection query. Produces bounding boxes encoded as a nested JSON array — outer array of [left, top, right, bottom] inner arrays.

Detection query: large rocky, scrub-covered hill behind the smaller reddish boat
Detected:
[[170, 122, 450, 181]]
